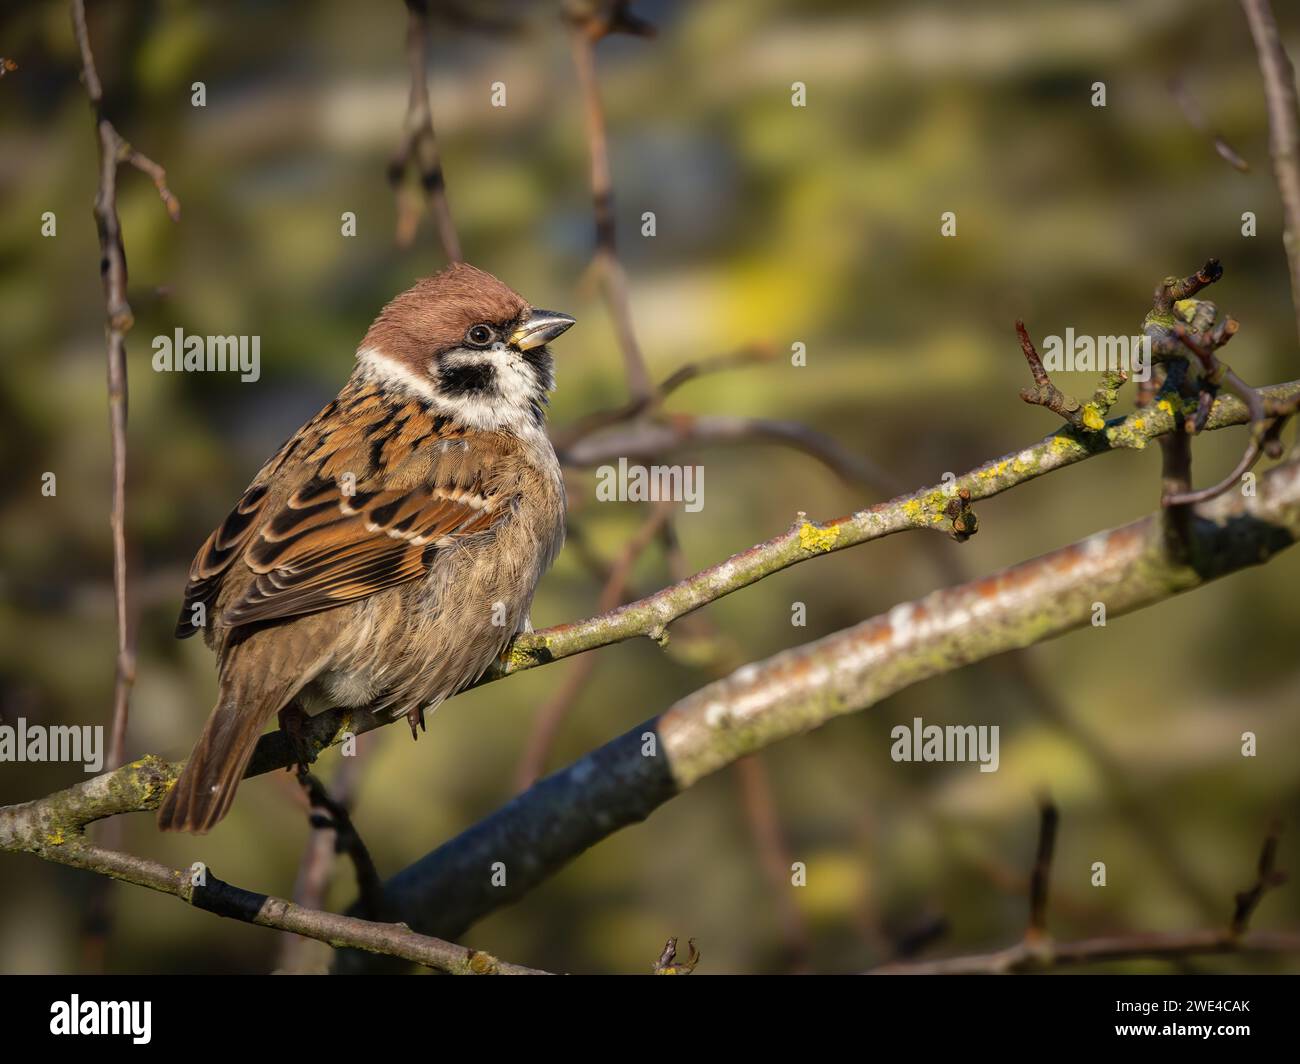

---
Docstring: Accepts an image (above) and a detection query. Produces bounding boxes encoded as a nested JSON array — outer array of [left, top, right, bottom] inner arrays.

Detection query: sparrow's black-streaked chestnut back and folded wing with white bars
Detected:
[[177, 392, 514, 637]]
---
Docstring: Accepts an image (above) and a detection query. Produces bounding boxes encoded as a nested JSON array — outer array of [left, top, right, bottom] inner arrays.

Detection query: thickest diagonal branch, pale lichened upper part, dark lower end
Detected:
[[341, 447, 1300, 963]]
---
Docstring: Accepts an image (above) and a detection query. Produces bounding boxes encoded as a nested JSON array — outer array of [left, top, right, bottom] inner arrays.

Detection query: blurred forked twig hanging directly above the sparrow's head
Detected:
[[389, 0, 462, 263]]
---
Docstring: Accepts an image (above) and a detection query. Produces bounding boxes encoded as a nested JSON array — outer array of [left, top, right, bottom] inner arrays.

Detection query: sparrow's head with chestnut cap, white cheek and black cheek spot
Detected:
[[356, 263, 573, 431]]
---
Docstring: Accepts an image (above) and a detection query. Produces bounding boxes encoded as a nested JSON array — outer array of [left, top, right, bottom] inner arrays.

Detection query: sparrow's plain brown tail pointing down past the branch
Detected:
[[159, 684, 287, 835]]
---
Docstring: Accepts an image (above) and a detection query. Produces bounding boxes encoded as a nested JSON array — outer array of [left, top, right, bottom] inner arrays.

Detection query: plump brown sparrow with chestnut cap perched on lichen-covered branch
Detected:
[[157, 263, 573, 832]]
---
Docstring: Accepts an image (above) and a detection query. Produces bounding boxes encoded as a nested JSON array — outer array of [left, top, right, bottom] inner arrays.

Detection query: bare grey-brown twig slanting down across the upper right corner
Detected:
[[1242, 0, 1300, 334]]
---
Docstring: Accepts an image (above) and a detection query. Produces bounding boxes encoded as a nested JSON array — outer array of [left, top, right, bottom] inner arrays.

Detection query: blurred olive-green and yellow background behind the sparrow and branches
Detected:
[[0, 0, 1300, 972]]
